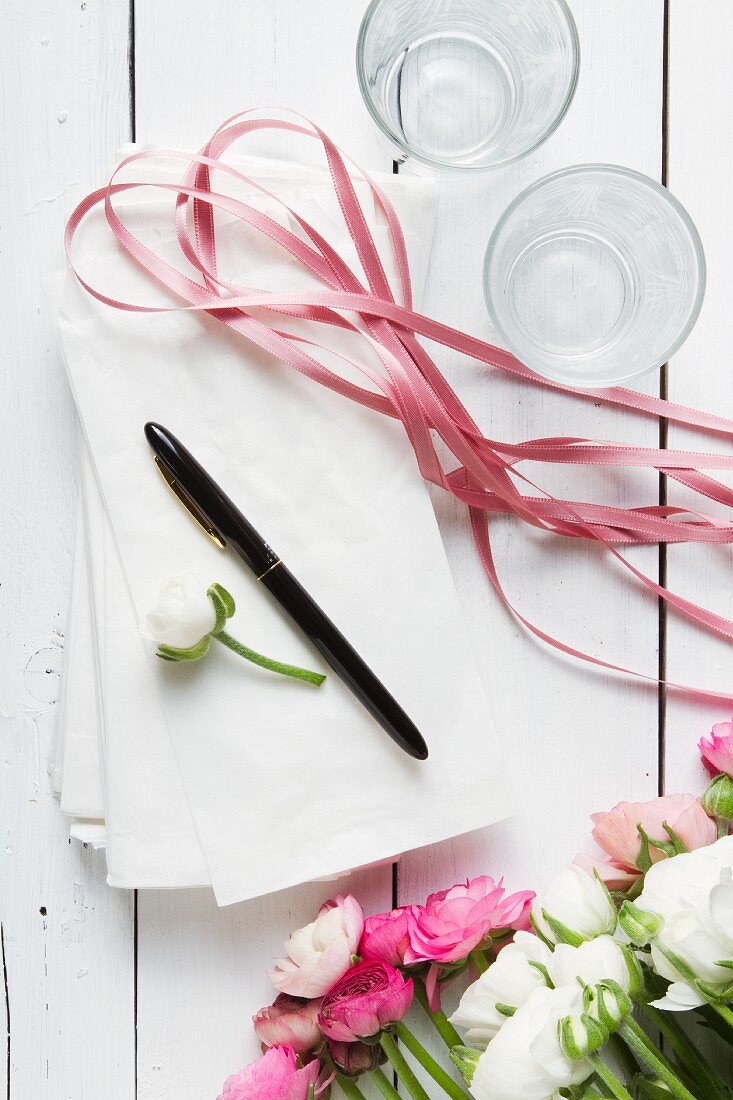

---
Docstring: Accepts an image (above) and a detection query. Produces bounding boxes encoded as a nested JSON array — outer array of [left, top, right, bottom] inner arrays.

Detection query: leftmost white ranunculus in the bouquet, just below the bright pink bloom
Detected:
[[450, 932, 553, 1048]]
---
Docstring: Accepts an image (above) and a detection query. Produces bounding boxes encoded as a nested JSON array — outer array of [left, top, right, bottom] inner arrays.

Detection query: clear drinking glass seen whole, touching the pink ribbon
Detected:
[[484, 164, 705, 387]]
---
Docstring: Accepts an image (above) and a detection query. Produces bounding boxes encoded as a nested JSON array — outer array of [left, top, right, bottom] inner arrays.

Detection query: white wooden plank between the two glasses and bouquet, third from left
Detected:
[[398, 0, 663, 1016]]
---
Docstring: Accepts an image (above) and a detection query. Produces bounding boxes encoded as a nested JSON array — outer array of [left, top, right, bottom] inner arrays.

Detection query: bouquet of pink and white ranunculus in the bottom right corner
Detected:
[[219, 723, 733, 1100]]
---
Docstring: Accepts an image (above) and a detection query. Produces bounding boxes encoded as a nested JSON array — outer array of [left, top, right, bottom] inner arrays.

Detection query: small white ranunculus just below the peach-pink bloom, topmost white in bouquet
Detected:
[[532, 865, 616, 943]]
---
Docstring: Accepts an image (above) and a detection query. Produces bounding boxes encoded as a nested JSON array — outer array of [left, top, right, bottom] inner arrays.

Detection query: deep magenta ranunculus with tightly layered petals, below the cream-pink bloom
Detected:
[[318, 963, 413, 1043]]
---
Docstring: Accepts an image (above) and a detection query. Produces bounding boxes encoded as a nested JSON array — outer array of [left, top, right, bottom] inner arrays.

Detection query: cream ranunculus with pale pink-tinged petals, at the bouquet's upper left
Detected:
[[270, 894, 364, 999]]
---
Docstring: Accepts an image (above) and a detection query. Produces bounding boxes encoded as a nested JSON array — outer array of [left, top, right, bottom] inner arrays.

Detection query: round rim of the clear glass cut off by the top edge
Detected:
[[355, 0, 580, 173]]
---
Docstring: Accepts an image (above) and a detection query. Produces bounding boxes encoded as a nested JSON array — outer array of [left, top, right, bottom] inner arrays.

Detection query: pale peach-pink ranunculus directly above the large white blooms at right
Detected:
[[576, 794, 718, 890]]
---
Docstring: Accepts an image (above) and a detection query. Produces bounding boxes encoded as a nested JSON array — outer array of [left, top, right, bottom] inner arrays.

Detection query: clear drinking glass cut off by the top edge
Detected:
[[357, 0, 579, 171]]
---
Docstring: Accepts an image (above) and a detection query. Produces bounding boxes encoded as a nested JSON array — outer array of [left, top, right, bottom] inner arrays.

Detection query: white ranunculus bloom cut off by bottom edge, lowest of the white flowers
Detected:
[[464, 986, 592, 1100]]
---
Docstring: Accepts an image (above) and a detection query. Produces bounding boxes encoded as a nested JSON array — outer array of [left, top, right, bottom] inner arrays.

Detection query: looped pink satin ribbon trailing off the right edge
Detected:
[[65, 108, 733, 702]]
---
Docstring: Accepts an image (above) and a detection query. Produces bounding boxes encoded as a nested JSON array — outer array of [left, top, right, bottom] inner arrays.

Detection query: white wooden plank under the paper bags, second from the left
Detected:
[[135, 0, 392, 1100]]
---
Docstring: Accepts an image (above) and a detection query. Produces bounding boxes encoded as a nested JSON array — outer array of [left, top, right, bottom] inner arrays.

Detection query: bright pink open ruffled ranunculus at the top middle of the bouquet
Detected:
[[405, 875, 535, 966]]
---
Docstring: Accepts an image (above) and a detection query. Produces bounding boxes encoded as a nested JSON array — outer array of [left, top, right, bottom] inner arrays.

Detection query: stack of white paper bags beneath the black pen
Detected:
[[50, 146, 510, 904]]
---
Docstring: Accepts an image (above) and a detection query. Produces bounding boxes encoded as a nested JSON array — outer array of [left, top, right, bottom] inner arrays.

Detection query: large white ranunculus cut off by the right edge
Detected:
[[635, 836, 733, 1011]]
